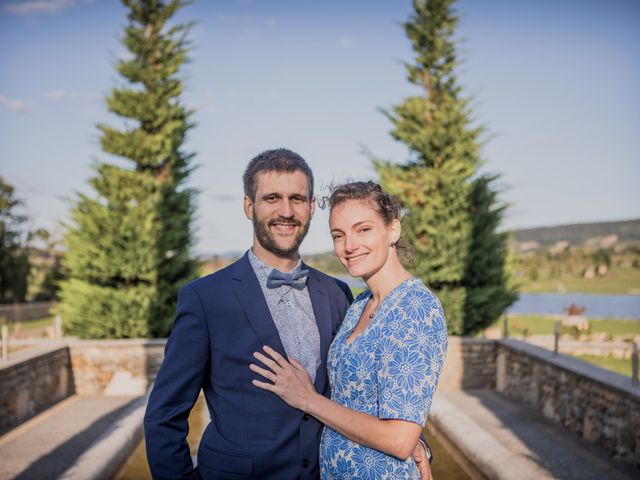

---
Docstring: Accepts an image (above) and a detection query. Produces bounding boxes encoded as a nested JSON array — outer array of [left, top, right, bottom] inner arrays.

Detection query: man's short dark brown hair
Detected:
[[242, 148, 313, 202]]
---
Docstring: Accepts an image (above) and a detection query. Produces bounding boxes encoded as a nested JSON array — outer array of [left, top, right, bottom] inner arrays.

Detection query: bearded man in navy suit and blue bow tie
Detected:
[[144, 149, 426, 480]]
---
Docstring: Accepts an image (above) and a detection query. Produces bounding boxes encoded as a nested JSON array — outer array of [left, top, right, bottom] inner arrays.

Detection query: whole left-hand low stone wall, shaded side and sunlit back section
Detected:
[[0, 339, 166, 432]]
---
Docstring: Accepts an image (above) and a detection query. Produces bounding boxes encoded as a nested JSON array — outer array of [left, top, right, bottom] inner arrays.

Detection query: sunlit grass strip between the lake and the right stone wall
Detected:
[[484, 314, 640, 336]]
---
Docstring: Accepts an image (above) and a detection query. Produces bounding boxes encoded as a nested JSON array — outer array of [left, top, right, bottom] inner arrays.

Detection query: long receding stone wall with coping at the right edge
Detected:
[[496, 340, 640, 466]]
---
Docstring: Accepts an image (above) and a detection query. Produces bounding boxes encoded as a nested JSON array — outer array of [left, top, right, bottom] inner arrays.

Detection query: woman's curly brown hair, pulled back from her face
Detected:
[[322, 181, 413, 263]]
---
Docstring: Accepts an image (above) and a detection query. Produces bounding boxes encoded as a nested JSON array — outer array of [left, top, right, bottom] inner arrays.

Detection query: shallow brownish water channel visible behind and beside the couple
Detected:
[[115, 395, 484, 480]]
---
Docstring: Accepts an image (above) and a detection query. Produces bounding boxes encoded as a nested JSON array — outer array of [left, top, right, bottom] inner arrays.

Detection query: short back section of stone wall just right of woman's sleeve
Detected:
[[438, 336, 496, 390]]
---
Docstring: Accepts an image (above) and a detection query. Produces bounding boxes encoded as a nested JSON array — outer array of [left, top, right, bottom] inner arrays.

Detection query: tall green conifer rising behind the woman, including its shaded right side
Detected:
[[374, 0, 515, 334]]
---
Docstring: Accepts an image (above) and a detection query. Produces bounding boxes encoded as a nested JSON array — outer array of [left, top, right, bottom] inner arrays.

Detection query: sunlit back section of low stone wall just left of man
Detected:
[[69, 339, 166, 395]]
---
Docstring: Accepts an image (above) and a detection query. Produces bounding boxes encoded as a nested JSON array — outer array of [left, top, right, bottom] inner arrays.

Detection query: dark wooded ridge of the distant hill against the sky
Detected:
[[512, 219, 640, 246]]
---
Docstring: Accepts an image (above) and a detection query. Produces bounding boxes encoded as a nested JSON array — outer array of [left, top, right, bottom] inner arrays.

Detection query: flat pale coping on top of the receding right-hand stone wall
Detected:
[[495, 339, 640, 401]]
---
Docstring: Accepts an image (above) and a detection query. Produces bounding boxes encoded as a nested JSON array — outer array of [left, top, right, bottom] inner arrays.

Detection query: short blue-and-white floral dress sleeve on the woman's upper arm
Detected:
[[378, 289, 447, 426]]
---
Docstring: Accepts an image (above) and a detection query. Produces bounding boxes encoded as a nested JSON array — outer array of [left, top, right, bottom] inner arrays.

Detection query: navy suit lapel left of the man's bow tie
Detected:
[[233, 254, 286, 357]]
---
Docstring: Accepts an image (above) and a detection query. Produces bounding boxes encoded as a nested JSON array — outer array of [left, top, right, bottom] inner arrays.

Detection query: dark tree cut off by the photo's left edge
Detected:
[[0, 176, 29, 303]]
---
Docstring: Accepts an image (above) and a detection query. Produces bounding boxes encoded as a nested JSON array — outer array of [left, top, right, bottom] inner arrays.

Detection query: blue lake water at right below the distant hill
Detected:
[[508, 293, 640, 320]]
